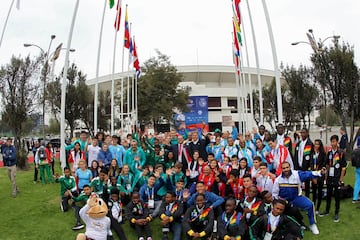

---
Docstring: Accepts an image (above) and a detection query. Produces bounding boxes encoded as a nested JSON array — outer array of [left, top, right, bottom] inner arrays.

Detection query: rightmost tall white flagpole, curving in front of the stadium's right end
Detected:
[[262, 0, 283, 123]]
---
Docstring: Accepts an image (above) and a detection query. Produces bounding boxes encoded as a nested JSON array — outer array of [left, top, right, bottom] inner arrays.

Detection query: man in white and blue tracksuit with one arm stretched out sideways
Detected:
[[273, 162, 324, 234]]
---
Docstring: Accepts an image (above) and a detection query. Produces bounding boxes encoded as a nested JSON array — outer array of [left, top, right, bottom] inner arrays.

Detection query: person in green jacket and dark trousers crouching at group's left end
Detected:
[[55, 167, 78, 212]]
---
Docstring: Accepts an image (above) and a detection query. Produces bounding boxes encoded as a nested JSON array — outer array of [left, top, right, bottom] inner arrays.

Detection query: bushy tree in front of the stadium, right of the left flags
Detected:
[[138, 51, 188, 127]]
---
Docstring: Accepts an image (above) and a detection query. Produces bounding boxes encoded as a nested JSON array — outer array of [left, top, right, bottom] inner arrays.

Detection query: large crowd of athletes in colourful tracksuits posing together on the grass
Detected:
[[16, 124, 360, 240]]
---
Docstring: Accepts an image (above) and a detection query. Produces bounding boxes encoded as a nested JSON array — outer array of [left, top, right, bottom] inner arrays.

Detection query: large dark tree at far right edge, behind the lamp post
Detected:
[[311, 42, 360, 152]]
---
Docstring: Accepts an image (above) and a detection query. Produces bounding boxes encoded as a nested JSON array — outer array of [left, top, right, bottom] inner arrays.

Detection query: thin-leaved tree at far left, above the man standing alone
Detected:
[[0, 56, 39, 169]]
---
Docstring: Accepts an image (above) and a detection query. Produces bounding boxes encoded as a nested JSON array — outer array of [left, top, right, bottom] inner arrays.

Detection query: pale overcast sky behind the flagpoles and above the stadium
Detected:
[[0, 0, 360, 79]]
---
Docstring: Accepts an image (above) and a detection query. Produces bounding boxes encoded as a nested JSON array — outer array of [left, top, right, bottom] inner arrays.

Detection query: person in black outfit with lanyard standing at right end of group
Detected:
[[319, 135, 346, 222]]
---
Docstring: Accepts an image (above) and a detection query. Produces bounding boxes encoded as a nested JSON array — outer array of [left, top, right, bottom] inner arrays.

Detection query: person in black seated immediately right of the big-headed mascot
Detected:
[[107, 188, 127, 240]]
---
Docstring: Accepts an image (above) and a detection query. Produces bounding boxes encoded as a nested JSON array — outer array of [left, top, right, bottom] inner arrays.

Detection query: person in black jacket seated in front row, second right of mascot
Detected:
[[126, 192, 152, 240]]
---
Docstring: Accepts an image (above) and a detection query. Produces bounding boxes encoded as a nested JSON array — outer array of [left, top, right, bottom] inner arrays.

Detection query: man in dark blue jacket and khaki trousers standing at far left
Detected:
[[1, 138, 19, 198]]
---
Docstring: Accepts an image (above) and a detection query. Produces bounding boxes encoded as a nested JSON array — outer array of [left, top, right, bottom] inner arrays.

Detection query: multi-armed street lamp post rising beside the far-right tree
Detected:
[[291, 29, 340, 144]]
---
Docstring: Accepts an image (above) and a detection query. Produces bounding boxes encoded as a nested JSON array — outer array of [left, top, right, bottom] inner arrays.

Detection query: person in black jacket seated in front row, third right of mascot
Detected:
[[160, 191, 183, 240]]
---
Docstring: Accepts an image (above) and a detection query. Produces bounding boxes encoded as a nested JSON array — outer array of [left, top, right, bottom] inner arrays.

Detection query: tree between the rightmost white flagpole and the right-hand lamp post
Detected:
[[282, 65, 319, 129]]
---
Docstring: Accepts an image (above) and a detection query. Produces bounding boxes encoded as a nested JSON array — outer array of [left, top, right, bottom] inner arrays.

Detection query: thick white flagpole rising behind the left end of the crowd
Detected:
[[60, 0, 80, 169]]
